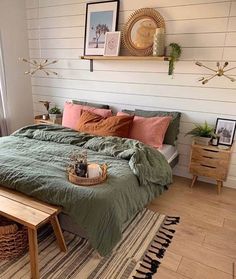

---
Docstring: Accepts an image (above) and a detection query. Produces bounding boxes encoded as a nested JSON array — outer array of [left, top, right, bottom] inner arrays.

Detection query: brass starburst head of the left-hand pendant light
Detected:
[[19, 58, 58, 76]]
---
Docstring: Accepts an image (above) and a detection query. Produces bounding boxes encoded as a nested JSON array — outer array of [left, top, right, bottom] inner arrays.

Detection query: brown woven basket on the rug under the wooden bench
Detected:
[[0, 216, 28, 260]]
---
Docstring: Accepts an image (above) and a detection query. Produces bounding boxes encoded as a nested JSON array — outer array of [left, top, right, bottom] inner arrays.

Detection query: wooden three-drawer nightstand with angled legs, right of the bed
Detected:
[[189, 144, 231, 194]]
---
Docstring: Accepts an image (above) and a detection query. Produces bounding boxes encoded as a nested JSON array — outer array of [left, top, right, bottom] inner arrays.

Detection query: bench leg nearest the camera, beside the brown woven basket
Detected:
[[28, 228, 39, 279]]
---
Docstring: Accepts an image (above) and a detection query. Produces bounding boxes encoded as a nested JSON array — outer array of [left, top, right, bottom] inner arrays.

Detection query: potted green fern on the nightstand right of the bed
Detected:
[[186, 121, 214, 145]]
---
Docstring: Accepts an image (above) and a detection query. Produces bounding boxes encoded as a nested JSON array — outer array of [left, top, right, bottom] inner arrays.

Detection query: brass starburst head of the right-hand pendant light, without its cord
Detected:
[[195, 61, 236, 84]]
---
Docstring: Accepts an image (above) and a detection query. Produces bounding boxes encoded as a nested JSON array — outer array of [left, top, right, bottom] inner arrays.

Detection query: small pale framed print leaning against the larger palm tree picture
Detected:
[[104, 31, 121, 56]]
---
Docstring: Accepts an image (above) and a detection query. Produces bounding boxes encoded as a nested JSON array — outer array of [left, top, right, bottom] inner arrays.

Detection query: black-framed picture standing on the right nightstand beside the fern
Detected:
[[215, 118, 236, 146]]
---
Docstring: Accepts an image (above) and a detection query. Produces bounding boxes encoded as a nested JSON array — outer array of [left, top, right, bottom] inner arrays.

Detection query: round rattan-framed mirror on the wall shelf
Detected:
[[122, 8, 165, 56]]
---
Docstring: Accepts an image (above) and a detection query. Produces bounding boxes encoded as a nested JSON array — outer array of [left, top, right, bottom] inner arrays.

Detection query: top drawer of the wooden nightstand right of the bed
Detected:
[[192, 145, 230, 160]]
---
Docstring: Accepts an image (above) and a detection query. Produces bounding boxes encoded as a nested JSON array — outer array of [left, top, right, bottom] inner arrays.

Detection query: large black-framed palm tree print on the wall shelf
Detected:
[[84, 0, 119, 55]]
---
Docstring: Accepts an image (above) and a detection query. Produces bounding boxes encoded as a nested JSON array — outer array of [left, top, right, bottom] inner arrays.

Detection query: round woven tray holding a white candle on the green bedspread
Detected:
[[69, 164, 107, 186]]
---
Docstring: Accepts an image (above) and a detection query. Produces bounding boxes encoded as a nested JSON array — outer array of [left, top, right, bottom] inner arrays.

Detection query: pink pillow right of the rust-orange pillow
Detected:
[[117, 112, 172, 148]]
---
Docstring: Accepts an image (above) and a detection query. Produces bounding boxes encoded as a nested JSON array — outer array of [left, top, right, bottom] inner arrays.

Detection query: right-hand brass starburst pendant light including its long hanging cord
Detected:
[[195, 0, 236, 84]]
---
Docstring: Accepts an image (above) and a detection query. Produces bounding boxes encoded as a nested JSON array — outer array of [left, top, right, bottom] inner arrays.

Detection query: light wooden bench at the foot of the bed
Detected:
[[0, 187, 67, 279]]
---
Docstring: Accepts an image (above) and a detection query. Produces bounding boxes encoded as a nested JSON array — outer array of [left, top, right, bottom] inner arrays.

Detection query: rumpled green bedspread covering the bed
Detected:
[[0, 125, 172, 256]]
